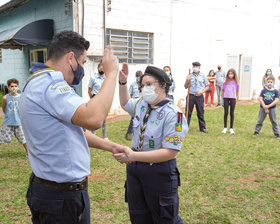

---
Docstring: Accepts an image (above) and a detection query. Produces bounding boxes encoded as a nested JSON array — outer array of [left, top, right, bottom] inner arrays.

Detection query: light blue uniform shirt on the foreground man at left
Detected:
[[20, 63, 90, 183]]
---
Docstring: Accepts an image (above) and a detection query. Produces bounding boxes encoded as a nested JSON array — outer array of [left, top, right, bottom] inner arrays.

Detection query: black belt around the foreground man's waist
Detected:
[[31, 173, 88, 191]]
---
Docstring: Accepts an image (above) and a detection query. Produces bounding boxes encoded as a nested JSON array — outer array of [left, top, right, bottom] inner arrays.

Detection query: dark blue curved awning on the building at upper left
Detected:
[[0, 19, 54, 49]]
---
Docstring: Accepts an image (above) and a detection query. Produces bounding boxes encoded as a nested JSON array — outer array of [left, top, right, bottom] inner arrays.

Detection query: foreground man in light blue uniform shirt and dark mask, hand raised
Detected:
[[20, 31, 128, 224]]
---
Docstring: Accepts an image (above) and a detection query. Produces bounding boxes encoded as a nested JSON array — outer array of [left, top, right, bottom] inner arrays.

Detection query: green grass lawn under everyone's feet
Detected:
[[0, 104, 280, 224]]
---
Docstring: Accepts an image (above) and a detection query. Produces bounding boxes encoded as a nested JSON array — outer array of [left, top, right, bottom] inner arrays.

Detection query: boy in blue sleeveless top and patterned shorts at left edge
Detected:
[[0, 79, 28, 153]]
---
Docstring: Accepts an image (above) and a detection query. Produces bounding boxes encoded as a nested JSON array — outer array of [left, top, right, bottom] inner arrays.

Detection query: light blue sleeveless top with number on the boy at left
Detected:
[[2, 94, 21, 126]]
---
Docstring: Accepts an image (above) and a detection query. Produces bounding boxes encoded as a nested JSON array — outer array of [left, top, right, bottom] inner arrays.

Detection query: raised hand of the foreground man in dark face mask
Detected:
[[102, 45, 119, 76]]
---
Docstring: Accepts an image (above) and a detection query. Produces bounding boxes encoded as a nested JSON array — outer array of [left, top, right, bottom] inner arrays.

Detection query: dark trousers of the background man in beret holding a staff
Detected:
[[186, 94, 206, 131]]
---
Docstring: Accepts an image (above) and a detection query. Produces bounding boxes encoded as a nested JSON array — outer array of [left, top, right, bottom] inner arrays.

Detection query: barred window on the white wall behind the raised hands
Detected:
[[106, 29, 153, 64]]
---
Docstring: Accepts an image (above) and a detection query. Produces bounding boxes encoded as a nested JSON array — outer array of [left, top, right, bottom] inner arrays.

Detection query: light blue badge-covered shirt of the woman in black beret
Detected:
[[125, 98, 189, 151]]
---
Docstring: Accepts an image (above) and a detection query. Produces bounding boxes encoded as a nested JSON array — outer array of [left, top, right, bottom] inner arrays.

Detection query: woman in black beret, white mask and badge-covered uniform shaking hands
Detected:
[[115, 64, 188, 224]]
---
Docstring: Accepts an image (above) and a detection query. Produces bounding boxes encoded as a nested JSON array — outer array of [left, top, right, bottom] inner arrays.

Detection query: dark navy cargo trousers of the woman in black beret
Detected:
[[125, 159, 183, 224]]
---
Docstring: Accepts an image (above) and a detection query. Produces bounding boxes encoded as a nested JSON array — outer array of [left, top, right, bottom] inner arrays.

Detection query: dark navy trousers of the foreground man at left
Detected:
[[26, 177, 90, 224]]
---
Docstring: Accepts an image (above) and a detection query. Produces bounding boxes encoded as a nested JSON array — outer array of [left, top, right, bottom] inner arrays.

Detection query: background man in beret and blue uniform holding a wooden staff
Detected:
[[185, 62, 209, 133]]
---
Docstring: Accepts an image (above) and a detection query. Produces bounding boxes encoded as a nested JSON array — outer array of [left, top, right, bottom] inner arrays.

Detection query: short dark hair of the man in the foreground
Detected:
[[48, 30, 89, 59]]
